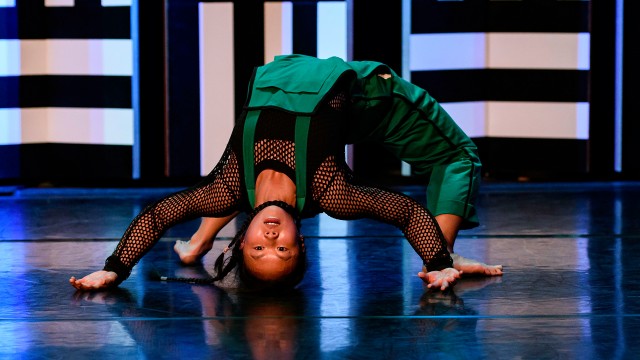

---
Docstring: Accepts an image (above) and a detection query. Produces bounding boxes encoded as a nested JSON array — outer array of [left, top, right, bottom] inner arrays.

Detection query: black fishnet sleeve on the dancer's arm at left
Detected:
[[104, 147, 241, 283]]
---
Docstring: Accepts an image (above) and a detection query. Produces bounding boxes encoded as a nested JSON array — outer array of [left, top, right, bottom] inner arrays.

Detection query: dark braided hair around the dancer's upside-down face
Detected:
[[211, 200, 307, 290]]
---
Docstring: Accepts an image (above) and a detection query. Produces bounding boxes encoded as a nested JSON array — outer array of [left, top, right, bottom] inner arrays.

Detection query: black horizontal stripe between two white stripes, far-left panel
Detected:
[[0, 75, 131, 109]]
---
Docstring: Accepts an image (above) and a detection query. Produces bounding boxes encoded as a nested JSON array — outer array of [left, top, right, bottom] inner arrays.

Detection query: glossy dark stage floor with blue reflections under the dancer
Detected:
[[0, 182, 640, 360]]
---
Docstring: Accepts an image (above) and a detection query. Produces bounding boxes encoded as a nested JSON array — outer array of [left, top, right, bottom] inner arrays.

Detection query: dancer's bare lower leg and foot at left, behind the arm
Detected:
[[173, 213, 237, 265]]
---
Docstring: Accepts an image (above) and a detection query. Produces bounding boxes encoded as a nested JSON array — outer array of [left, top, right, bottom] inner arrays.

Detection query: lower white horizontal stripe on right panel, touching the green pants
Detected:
[[441, 101, 589, 140]]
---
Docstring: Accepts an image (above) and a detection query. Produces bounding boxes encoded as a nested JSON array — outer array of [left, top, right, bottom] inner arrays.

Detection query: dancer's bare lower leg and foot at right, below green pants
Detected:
[[436, 214, 502, 276]]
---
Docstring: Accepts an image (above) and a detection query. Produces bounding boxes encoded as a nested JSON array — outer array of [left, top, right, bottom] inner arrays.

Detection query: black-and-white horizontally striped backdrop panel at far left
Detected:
[[0, 0, 133, 180]]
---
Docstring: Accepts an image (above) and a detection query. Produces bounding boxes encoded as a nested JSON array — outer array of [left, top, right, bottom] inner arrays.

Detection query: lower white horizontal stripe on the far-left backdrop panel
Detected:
[[0, 108, 133, 145]]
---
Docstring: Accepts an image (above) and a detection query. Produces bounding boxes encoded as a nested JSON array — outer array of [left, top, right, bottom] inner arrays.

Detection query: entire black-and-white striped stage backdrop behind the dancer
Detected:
[[0, 0, 624, 180]]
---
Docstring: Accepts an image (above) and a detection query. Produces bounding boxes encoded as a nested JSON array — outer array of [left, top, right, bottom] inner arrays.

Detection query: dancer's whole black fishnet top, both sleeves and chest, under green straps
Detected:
[[105, 92, 452, 282]]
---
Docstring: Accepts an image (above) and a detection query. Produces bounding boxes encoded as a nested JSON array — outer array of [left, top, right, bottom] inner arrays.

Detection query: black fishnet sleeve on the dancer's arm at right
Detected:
[[317, 160, 453, 271]]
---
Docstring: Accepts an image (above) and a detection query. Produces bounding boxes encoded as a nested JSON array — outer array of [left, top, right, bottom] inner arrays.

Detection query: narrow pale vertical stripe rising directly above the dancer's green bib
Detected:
[[264, 1, 293, 64]]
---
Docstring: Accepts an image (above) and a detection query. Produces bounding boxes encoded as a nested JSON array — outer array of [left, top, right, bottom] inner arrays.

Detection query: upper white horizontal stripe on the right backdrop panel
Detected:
[[409, 33, 590, 71]]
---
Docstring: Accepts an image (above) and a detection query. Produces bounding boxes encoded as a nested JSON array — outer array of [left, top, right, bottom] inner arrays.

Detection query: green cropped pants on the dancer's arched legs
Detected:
[[352, 71, 481, 229]]
